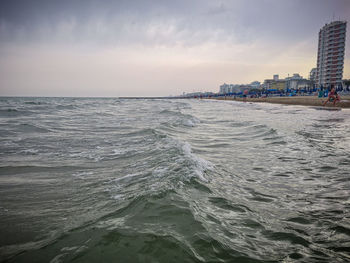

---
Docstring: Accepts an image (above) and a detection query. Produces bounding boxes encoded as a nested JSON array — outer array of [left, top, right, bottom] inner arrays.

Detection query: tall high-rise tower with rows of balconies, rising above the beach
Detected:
[[316, 21, 346, 87]]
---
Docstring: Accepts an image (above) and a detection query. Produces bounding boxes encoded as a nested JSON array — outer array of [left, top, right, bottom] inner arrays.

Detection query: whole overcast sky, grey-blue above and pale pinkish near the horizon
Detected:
[[0, 0, 350, 97]]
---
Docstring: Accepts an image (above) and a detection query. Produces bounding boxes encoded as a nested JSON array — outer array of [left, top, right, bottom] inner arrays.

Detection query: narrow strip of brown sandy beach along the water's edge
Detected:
[[214, 96, 350, 108]]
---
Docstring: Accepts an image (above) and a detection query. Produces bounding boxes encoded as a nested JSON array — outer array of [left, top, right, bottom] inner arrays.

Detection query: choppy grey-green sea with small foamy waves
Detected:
[[0, 97, 350, 263]]
